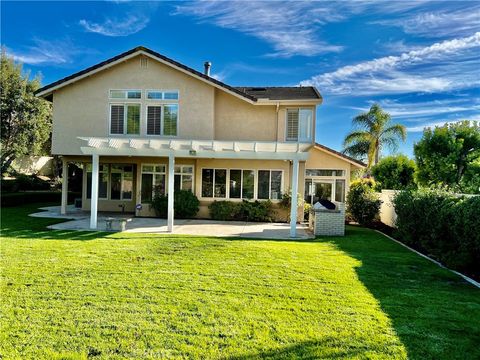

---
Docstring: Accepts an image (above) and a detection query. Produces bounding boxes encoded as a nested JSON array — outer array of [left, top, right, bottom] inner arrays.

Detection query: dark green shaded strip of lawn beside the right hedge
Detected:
[[322, 227, 480, 359]]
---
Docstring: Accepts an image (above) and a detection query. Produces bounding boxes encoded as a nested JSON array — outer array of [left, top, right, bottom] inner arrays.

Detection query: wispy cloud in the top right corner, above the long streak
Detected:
[[374, 2, 480, 37]]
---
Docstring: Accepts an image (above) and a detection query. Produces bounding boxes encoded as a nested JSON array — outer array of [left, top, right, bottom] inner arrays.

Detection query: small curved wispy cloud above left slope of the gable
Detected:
[[79, 13, 150, 37]]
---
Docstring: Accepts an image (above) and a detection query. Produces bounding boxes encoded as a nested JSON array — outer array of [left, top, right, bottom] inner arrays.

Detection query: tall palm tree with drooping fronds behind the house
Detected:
[[343, 104, 407, 169]]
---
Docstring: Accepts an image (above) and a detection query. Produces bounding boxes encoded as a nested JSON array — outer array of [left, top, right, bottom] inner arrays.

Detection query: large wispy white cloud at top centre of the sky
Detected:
[[175, 1, 344, 57]]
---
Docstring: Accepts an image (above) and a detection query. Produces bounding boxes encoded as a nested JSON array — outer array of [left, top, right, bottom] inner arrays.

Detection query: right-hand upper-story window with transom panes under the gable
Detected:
[[146, 90, 178, 136]]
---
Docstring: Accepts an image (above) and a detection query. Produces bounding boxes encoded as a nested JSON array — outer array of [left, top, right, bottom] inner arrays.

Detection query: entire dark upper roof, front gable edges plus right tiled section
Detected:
[[35, 46, 322, 104]]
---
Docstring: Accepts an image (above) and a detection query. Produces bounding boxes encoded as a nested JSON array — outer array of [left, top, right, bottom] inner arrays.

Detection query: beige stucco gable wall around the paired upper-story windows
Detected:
[[52, 56, 214, 155]]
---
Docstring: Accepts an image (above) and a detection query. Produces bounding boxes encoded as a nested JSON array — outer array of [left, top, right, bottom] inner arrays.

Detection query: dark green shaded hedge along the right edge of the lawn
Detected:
[[393, 190, 480, 279]]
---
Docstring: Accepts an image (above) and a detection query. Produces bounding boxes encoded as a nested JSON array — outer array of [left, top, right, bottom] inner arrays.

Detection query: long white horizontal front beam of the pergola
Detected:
[[80, 146, 309, 161]]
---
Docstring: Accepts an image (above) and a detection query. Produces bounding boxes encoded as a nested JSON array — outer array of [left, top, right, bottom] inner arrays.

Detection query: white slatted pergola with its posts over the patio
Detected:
[[61, 138, 312, 237]]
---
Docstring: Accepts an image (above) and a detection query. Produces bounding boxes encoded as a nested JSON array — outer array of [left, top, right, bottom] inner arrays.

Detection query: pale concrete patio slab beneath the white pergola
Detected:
[[30, 205, 314, 239]]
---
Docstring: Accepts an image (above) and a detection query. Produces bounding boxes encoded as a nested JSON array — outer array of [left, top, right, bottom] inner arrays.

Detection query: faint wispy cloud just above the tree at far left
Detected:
[[7, 38, 90, 65]]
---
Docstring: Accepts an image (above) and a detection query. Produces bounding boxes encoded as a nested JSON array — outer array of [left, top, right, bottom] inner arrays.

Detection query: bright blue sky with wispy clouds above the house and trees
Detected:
[[1, 0, 480, 156]]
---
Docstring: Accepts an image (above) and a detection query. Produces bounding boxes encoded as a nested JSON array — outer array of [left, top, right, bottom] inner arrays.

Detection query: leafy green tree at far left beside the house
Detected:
[[0, 49, 51, 175]]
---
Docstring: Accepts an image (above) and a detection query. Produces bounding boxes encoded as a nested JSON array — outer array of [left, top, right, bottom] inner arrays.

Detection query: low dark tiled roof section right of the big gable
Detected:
[[235, 86, 322, 100]]
